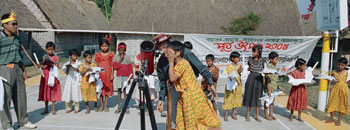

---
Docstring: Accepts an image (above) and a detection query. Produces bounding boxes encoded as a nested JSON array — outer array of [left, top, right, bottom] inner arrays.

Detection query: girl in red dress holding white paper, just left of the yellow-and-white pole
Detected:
[[287, 58, 307, 122]]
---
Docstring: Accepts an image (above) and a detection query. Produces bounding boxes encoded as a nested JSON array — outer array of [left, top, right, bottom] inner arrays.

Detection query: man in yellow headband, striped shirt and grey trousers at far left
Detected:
[[0, 12, 36, 130]]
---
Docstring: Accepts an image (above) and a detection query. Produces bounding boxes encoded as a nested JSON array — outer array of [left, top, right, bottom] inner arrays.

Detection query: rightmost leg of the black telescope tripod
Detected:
[[143, 80, 157, 130]]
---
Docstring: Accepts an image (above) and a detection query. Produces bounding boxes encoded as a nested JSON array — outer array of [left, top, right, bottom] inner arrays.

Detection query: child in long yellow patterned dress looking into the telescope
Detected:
[[166, 41, 221, 130]]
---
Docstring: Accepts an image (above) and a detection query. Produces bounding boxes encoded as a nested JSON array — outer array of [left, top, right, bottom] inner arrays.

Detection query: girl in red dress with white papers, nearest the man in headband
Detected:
[[38, 42, 61, 115]]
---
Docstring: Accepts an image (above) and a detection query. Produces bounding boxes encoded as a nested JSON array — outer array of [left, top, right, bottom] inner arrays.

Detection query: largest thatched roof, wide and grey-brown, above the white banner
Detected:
[[110, 0, 316, 36]]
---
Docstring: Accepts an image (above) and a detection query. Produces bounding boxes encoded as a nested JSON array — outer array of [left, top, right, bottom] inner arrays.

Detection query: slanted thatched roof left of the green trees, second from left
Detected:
[[34, 0, 108, 30]]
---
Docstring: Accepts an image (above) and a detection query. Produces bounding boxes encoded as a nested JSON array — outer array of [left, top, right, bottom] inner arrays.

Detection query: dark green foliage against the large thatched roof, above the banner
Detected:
[[221, 12, 261, 35]]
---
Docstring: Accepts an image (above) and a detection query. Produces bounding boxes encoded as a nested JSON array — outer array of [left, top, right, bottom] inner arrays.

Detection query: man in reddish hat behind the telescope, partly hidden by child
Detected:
[[152, 34, 214, 128]]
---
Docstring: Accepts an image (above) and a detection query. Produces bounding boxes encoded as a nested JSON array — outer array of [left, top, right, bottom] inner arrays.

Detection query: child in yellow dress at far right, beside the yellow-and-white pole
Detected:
[[326, 58, 349, 126]]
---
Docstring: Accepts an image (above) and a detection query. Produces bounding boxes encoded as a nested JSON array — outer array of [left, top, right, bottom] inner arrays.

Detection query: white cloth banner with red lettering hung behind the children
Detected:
[[184, 35, 321, 77]]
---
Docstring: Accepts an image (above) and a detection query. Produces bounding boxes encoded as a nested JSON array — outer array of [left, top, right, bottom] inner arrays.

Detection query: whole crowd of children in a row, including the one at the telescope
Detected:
[[34, 40, 349, 129]]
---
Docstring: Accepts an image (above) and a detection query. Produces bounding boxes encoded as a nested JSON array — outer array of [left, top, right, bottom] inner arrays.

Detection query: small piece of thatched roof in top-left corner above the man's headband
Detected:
[[0, 0, 44, 29]]
